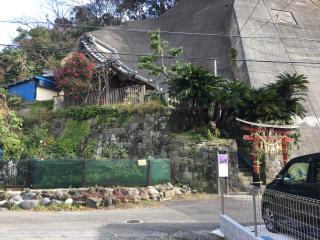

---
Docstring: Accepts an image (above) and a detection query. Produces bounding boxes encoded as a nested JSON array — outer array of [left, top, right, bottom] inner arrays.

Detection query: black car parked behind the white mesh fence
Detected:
[[261, 153, 320, 239]]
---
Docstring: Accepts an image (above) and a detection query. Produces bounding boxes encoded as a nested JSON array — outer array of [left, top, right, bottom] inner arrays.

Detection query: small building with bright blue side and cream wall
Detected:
[[3, 76, 60, 102]]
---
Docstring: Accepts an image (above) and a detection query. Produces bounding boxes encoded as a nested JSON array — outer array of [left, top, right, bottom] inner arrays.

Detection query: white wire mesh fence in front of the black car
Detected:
[[221, 180, 320, 240]]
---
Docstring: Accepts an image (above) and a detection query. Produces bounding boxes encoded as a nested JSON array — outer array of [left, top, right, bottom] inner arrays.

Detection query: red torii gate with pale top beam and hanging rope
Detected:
[[237, 118, 299, 185]]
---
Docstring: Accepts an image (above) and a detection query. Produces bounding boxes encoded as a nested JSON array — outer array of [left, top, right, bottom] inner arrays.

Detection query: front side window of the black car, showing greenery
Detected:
[[283, 162, 310, 184]]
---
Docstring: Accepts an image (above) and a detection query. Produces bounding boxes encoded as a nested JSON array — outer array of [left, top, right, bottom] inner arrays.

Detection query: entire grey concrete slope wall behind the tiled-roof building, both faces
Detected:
[[87, 0, 320, 155]]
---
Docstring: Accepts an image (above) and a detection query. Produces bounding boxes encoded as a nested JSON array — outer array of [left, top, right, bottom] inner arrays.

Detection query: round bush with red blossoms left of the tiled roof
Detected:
[[54, 52, 96, 96]]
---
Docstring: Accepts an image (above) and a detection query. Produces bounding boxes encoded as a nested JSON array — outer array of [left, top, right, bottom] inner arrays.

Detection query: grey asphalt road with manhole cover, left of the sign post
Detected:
[[0, 199, 220, 240]]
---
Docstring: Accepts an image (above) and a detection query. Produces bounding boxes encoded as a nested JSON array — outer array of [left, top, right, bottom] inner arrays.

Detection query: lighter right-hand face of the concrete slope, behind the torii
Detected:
[[233, 0, 320, 155]]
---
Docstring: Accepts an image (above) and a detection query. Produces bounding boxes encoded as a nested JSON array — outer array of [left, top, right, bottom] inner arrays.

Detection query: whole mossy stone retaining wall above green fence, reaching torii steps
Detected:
[[54, 110, 239, 192]]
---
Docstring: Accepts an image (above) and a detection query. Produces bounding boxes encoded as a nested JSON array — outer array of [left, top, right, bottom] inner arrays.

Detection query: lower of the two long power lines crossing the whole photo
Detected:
[[0, 43, 320, 65]]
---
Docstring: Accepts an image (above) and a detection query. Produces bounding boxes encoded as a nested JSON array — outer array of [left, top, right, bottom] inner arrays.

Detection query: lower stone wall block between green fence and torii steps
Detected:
[[169, 138, 240, 192]]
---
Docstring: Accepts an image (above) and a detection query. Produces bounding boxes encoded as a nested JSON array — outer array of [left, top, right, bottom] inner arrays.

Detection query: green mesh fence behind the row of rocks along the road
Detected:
[[0, 158, 171, 188]]
